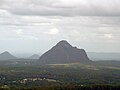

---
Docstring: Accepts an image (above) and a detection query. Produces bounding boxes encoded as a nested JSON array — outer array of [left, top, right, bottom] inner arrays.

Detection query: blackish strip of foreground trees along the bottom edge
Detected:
[[0, 85, 120, 90]]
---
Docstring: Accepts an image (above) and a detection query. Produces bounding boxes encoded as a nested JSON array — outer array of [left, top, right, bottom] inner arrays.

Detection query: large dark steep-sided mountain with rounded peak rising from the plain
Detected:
[[39, 40, 91, 64]]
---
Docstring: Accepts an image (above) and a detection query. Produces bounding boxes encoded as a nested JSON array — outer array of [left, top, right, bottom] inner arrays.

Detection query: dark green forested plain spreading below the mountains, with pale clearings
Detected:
[[0, 61, 120, 90]]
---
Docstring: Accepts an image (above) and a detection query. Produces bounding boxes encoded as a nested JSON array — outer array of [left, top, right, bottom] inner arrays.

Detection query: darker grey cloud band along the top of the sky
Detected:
[[0, 0, 120, 16]]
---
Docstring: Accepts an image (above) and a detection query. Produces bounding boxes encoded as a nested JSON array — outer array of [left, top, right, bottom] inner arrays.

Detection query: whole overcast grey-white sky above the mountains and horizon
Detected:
[[0, 0, 120, 53]]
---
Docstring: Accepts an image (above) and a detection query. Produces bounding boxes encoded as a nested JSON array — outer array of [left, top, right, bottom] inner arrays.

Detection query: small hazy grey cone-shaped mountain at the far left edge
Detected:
[[0, 51, 17, 60]]
